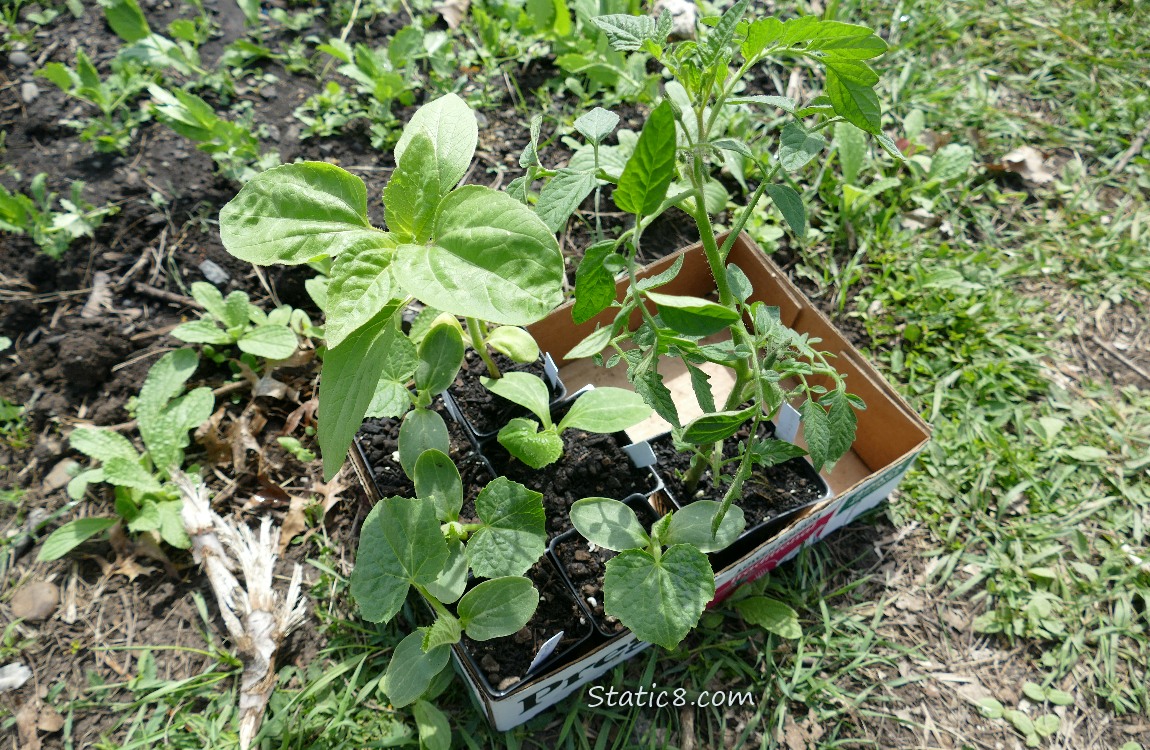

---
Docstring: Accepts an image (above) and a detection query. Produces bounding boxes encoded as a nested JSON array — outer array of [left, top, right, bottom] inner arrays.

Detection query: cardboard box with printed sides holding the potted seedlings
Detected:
[[354, 235, 930, 730]]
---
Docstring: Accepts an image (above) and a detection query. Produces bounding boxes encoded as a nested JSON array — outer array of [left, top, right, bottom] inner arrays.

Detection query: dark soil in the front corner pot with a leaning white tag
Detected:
[[463, 558, 591, 690]]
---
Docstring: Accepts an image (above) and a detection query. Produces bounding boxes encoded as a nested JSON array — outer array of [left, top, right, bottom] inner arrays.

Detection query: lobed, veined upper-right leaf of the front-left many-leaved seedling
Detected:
[[467, 476, 547, 579]]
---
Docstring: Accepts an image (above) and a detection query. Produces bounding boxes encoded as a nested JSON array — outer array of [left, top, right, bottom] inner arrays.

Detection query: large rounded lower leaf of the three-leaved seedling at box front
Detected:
[[604, 544, 715, 649]]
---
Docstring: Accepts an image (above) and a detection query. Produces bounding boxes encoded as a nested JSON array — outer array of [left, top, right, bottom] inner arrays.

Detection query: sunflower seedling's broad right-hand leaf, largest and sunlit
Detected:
[[393, 185, 564, 326]]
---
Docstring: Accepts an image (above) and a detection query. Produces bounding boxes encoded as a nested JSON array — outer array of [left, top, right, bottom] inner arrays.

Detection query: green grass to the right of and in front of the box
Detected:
[[11, 0, 1150, 750]]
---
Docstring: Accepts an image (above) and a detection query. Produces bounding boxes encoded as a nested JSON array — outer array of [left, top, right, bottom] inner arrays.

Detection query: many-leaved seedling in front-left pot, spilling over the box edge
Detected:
[[351, 439, 547, 706]]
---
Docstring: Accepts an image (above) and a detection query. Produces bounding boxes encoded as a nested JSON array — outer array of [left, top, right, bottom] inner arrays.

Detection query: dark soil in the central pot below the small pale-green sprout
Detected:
[[483, 415, 657, 538]]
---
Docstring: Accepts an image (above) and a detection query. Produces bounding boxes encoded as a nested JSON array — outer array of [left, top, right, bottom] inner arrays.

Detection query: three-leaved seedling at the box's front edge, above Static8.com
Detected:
[[570, 494, 746, 649]]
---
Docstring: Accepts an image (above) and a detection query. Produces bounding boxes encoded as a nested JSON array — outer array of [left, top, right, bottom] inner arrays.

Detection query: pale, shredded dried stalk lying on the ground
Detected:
[[173, 472, 307, 750]]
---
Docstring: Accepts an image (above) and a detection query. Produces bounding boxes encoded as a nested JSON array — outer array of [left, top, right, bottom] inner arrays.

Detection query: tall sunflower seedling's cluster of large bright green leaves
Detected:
[[220, 94, 564, 479]]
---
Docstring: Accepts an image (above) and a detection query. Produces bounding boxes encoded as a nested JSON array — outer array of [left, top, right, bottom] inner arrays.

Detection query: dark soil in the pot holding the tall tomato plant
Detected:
[[651, 424, 826, 529]]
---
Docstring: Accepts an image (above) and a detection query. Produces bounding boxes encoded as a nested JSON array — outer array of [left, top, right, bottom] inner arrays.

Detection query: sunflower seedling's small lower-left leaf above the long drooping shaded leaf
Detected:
[[323, 235, 396, 349]]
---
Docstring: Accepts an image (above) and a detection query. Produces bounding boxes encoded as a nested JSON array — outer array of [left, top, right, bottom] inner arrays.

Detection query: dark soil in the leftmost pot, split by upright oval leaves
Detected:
[[355, 401, 492, 510]]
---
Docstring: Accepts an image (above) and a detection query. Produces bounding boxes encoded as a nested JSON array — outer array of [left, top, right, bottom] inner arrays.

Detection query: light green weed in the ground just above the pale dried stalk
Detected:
[[40, 349, 215, 560]]
